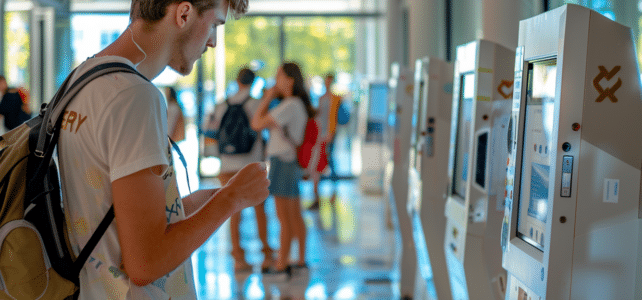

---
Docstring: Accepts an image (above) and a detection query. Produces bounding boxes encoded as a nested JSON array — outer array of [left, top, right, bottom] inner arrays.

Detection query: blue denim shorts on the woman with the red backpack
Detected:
[[268, 156, 303, 198]]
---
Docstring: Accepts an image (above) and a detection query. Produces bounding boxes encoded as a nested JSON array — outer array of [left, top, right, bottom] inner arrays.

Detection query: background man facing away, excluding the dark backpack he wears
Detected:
[[209, 68, 272, 273]]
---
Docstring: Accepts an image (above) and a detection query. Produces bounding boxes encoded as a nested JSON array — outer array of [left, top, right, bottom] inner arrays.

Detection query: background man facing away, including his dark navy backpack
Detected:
[[209, 68, 272, 273]]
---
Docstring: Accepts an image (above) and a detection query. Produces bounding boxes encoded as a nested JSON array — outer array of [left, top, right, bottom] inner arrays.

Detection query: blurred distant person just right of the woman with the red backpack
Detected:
[[308, 73, 341, 210]]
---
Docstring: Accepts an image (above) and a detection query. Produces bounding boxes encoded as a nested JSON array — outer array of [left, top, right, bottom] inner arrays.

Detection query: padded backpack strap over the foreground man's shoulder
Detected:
[[34, 62, 149, 157]]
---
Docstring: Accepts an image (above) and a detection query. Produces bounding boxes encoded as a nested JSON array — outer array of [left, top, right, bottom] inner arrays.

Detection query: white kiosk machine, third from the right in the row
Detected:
[[407, 57, 453, 300]]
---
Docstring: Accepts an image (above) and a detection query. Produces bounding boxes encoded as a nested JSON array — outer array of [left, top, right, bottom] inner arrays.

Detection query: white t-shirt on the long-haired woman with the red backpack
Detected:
[[267, 97, 308, 162]]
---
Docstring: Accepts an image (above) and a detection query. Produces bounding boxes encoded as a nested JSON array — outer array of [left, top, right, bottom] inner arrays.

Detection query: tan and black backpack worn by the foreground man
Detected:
[[0, 63, 144, 299]]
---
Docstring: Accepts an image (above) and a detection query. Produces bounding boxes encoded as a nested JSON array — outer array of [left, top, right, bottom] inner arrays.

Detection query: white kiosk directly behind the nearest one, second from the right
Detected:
[[443, 40, 515, 300]]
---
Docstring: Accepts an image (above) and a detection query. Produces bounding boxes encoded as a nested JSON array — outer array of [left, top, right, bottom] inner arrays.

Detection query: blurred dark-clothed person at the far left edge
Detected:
[[0, 75, 31, 130]]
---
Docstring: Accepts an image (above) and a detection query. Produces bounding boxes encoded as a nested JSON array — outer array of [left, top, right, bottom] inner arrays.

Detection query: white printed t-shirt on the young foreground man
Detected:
[[58, 56, 196, 300]]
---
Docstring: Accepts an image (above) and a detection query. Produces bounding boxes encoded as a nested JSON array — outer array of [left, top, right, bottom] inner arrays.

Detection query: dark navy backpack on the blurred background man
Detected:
[[218, 96, 258, 155]]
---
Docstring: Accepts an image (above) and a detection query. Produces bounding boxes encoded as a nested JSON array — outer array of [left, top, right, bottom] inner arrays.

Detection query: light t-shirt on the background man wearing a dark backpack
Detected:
[[211, 89, 263, 173]]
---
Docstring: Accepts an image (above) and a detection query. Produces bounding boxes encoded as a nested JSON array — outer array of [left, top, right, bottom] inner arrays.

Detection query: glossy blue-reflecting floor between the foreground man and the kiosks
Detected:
[[192, 180, 398, 299]]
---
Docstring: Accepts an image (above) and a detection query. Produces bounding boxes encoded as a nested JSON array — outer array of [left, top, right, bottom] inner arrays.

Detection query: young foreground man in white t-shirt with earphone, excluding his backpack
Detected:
[[58, 0, 269, 300]]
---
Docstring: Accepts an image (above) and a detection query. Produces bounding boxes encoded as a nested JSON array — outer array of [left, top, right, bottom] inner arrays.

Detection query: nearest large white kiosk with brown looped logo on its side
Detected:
[[502, 5, 642, 300]]
